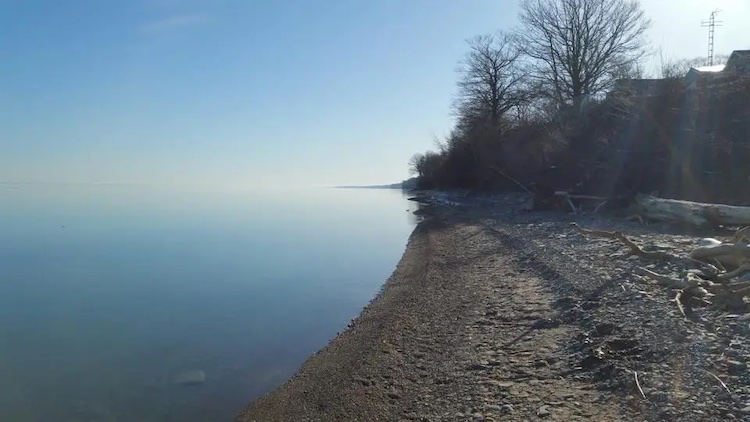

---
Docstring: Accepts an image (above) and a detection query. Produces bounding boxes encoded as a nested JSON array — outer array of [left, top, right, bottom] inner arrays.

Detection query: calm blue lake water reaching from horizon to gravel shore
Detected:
[[0, 184, 414, 422]]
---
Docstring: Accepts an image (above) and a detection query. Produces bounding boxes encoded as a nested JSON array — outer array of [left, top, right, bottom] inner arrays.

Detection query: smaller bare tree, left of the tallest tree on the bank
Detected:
[[453, 33, 526, 130]]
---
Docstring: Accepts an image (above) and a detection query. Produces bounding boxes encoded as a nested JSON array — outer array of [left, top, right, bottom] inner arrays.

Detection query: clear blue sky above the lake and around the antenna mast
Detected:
[[0, 0, 750, 186]]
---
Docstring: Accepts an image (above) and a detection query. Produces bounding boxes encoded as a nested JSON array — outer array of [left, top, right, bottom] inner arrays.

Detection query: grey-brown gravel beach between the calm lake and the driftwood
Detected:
[[236, 196, 750, 422]]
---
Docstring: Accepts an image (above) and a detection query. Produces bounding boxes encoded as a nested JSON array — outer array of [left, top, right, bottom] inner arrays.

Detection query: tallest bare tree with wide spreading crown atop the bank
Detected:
[[517, 0, 650, 110]]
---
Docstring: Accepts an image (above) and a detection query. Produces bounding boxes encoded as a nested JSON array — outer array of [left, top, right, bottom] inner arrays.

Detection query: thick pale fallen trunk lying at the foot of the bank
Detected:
[[634, 195, 750, 227]]
